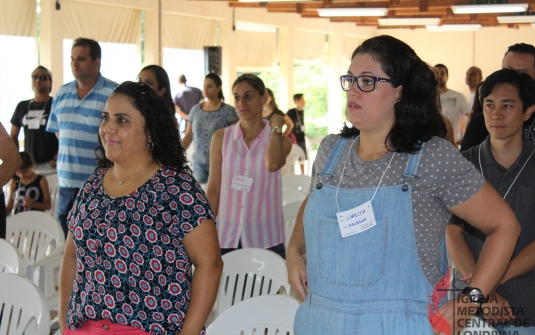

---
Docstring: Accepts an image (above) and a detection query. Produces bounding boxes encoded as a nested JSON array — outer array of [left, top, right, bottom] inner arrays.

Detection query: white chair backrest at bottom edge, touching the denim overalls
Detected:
[[206, 295, 299, 335]]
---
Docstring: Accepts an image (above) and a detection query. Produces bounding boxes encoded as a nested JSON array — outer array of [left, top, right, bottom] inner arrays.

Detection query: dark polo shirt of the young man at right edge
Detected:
[[452, 135, 535, 326]]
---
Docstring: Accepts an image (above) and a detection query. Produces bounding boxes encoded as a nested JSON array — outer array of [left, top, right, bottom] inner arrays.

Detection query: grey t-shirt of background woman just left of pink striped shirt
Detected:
[[189, 103, 238, 164]]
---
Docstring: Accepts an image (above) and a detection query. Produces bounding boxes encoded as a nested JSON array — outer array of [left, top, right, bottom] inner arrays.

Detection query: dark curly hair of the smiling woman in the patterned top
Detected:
[[95, 81, 191, 173]]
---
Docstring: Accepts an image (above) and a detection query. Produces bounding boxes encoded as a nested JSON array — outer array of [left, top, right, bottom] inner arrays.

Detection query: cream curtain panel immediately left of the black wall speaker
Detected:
[[162, 14, 217, 50]]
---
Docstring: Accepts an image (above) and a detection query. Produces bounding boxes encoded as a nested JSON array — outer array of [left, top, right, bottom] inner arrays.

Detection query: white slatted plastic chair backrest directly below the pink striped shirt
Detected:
[[217, 248, 290, 320]]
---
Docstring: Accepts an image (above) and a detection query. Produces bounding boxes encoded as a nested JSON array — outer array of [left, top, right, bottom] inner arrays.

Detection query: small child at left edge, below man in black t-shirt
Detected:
[[6, 152, 52, 214]]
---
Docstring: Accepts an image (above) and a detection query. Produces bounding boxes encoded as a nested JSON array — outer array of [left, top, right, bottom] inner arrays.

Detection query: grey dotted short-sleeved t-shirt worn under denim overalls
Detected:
[[310, 135, 484, 286]]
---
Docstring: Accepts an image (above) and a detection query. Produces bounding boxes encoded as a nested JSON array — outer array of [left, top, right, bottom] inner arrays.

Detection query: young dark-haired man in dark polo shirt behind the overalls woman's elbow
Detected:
[[447, 69, 535, 335]]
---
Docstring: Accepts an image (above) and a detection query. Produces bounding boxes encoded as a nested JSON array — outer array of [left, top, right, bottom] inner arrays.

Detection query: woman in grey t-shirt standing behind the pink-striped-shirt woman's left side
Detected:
[[182, 73, 238, 184]]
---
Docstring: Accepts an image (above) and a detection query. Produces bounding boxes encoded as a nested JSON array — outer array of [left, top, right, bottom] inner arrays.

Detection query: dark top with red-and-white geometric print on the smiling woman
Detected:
[[67, 166, 214, 335]]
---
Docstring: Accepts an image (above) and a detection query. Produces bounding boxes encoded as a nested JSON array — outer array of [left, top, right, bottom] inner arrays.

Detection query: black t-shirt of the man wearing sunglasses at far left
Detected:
[[11, 98, 58, 164]]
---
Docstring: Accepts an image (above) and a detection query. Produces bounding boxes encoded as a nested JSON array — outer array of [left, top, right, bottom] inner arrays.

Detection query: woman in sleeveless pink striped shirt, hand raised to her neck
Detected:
[[207, 74, 292, 257]]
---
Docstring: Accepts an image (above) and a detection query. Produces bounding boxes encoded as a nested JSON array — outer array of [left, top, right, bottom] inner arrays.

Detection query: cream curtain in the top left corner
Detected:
[[0, 0, 37, 37]]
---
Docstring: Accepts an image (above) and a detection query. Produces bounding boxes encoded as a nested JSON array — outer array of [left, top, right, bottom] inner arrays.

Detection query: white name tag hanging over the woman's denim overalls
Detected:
[[336, 201, 376, 237]]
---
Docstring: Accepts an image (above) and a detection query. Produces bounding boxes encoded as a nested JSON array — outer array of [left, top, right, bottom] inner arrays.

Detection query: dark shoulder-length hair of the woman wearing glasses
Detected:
[[342, 35, 446, 153]]
